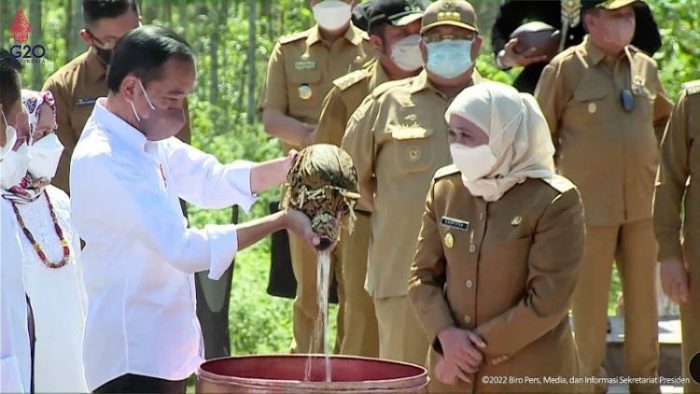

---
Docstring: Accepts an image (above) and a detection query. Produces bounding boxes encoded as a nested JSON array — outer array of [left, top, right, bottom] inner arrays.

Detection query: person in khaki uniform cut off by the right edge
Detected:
[[654, 80, 700, 393]]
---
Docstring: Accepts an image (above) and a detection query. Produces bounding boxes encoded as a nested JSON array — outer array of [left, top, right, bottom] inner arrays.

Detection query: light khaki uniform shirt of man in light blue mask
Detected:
[[342, 71, 476, 298]]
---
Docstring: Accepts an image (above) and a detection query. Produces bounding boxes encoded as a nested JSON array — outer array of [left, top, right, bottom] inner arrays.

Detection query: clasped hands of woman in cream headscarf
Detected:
[[438, 327, 486, 380]]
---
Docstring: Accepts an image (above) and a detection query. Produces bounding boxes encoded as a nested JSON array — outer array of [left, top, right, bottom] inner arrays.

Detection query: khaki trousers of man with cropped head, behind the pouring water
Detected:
[[287, 231, 345, 353]]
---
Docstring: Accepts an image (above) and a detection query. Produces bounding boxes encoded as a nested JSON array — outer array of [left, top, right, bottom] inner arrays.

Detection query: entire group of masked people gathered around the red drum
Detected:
[[0, 0, 700, 393]]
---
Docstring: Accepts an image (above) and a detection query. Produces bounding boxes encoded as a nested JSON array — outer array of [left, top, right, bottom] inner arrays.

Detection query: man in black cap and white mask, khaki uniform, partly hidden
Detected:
[[314, 0, 425, 357]]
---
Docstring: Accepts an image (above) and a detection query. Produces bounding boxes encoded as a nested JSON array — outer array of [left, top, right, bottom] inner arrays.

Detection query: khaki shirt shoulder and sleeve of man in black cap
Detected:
[[314, 60, 389, 146]]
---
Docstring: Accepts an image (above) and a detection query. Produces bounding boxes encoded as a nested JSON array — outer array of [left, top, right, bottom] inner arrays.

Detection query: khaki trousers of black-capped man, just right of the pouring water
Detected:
[[337, 211, 379, 357]]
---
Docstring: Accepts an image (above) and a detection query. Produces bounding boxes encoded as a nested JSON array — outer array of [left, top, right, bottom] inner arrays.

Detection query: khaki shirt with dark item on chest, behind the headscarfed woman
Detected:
[[535, 37, 671, 225]]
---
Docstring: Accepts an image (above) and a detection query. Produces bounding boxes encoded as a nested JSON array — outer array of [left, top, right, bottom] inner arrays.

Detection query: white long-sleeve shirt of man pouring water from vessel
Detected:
[[70, 98, 255, 391]]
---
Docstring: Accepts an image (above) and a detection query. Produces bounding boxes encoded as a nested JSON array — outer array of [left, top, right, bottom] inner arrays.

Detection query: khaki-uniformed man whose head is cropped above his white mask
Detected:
[[259, 0, 373, 353]]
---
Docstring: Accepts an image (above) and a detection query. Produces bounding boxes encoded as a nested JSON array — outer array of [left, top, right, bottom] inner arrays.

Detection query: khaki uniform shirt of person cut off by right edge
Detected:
[[654, 81, 700, 262]]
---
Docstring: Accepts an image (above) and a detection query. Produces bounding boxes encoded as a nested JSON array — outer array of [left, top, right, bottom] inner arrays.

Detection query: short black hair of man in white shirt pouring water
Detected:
[[107, 26, 194, 92]]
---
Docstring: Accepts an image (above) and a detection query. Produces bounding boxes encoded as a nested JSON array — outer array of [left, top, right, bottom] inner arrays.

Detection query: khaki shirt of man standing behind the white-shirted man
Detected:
[[42, 48, 190, 193]]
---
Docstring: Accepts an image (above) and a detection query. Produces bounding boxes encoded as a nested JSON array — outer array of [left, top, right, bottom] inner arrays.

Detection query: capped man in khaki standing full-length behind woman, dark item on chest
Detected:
[[535, 0, 671, 392]]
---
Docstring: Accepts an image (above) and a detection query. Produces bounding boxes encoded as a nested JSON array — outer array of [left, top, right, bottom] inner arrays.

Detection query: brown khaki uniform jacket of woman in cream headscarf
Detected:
[[409, 165, 585, 392]]
